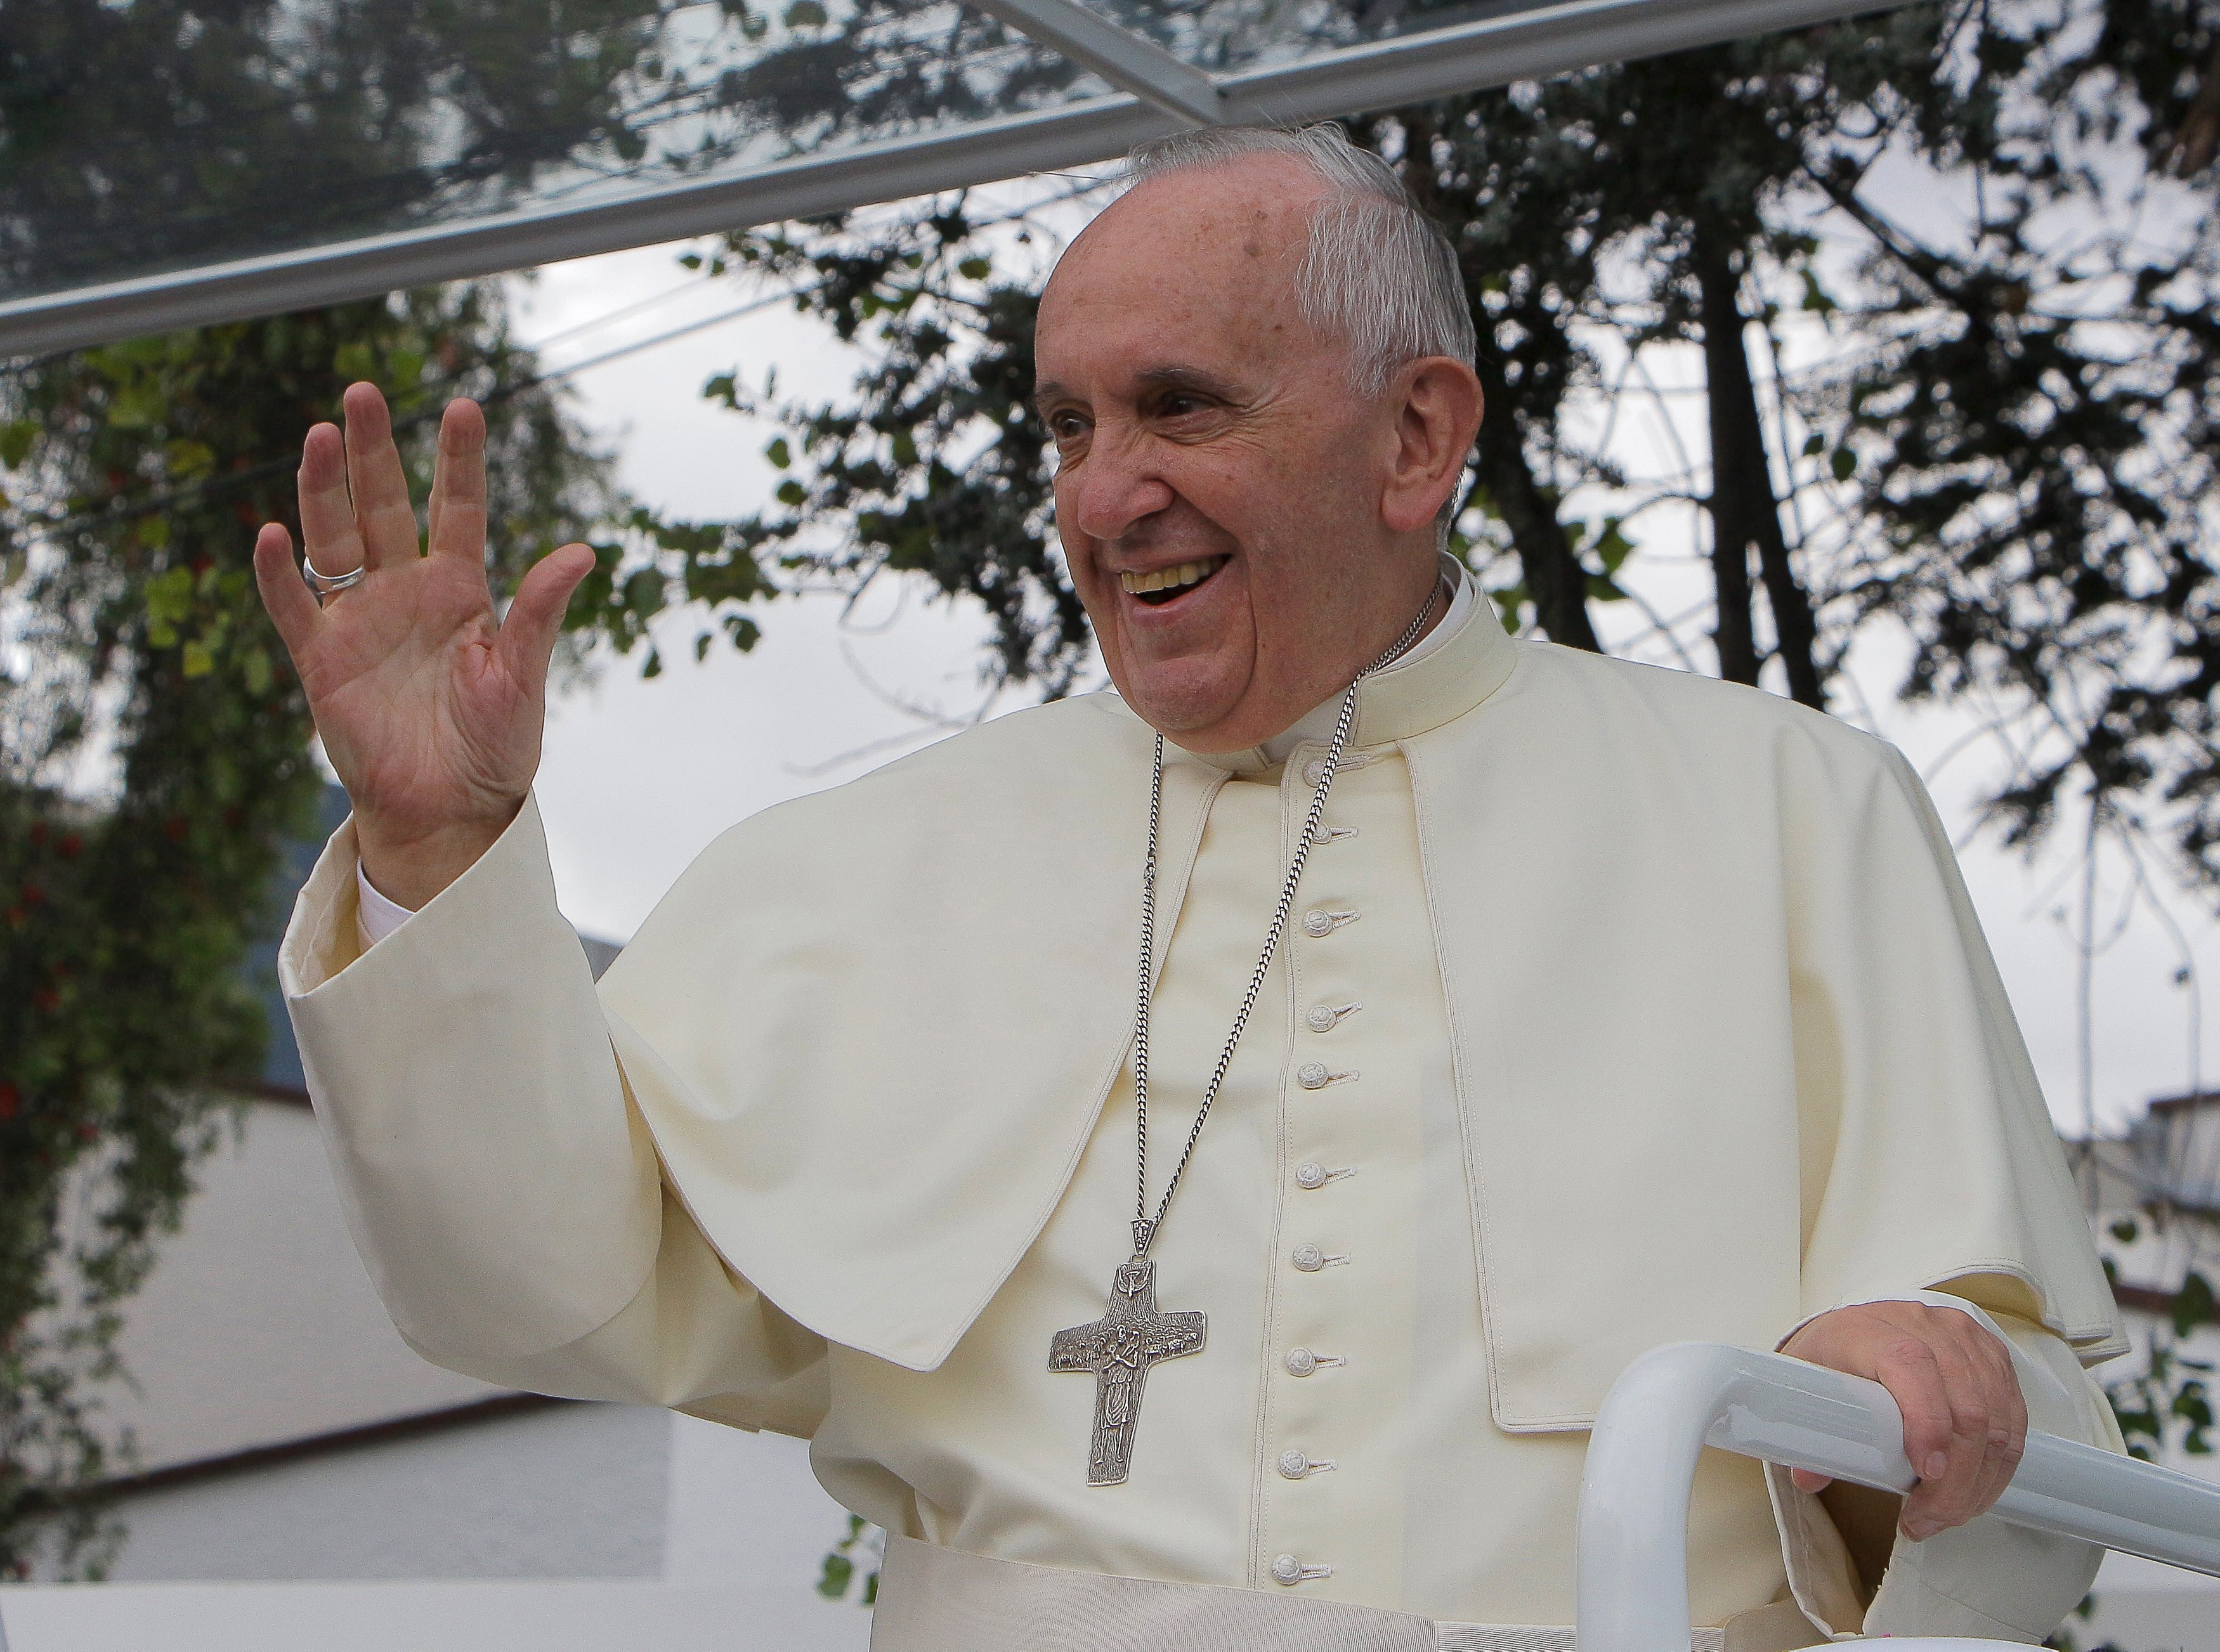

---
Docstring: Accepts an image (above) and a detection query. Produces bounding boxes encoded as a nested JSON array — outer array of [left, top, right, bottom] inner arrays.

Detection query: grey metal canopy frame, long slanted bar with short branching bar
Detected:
[[0, 0, 1900, 355]]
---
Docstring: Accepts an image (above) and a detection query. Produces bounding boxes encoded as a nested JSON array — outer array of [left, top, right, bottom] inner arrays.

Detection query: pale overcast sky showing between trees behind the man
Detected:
[[499, 219, 2220, 1128]]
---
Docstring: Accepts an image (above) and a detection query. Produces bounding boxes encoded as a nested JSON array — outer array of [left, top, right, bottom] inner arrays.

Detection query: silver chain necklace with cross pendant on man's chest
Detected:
[[1048, 586, 1441, 1485]]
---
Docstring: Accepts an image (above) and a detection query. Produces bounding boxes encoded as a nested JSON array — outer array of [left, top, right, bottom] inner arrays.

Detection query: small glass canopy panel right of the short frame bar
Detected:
[[1079, 0, 1572, 75]]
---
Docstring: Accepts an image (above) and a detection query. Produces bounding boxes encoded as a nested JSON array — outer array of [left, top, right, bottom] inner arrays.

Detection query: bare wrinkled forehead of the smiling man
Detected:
[[1035, 155, 1326, 380]]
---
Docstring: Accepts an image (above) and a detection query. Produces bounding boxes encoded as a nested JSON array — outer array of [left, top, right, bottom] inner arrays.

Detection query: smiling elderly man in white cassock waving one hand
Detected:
[[258, 129, 2118, 1652]]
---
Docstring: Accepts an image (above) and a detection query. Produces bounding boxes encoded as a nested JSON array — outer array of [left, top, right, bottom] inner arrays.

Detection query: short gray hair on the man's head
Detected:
[[1126, 124, 1479, 395]]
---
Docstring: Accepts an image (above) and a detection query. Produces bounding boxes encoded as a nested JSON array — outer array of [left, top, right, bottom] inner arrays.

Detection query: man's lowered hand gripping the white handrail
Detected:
[[1780, 1301, 2027, 1543]]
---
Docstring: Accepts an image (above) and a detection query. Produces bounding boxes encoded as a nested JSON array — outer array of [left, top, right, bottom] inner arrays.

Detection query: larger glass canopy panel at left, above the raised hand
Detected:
[[0, 0, 1110, 302]]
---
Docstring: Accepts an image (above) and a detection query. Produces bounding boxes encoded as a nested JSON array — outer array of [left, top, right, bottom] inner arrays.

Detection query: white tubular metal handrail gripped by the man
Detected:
[[1576, 1343, 2220, 1652]]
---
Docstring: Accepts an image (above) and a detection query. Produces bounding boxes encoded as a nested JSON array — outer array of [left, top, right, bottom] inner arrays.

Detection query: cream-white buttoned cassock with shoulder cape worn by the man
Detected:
[[282, 561, 2120, 1645]]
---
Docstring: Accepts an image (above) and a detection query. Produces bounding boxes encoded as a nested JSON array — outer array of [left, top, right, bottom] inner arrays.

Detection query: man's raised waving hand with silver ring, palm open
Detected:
[[256, 384, 593, 908]]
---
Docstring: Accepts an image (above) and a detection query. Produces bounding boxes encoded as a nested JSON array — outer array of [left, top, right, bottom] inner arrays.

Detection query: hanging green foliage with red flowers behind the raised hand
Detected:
[[0, 287, 615, 1574]]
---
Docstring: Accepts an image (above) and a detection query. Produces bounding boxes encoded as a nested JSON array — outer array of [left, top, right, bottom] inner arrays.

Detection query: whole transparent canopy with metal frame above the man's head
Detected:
[[0, 0, 1898, 355]]
